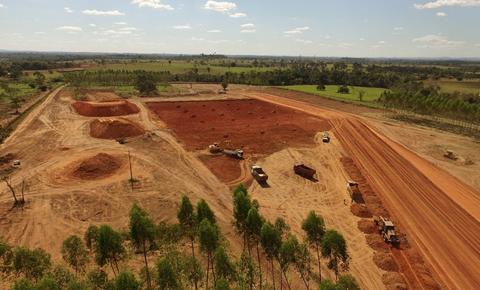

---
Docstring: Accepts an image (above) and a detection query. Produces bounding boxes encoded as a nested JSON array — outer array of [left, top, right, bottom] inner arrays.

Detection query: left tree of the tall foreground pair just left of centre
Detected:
[[177, 195, 198, 290]]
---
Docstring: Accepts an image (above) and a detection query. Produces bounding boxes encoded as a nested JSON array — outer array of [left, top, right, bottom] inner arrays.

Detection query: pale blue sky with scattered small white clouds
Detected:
[[0, 0, 480, 58]]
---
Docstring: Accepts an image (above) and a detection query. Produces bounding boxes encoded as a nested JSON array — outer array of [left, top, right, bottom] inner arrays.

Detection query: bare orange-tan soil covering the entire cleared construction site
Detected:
[[0, 87, 480, 289]]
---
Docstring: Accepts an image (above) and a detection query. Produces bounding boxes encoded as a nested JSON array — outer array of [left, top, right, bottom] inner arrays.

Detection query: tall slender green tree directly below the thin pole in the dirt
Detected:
[[129, 203, 155, 289]]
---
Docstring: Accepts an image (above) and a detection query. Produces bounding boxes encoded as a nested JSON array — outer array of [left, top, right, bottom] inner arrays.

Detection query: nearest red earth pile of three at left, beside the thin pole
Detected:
[[72, 153, 122, 180]]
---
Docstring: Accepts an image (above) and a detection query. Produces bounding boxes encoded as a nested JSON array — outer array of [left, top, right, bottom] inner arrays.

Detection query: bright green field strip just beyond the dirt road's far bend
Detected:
[[283, 85, 385, 104]]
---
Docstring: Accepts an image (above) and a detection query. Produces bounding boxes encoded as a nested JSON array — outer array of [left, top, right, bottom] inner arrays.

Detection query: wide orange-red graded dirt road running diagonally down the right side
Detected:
[[250, 94, 480, 289]]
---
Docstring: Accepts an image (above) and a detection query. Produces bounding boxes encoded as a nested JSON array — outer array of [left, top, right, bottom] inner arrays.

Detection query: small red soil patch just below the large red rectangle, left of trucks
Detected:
[[200, 155, 241, 183]]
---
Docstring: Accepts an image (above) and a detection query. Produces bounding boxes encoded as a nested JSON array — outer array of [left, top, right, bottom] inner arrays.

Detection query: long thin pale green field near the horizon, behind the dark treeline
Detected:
[[89, 60, 274, 74]]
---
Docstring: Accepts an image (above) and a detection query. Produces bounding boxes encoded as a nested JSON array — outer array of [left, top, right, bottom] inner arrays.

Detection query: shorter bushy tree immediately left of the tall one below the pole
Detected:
[[95, 225, 125, 275]]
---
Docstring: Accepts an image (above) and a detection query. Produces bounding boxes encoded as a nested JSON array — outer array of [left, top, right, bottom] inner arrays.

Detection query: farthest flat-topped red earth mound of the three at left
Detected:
[[72, 101, 140, 117]]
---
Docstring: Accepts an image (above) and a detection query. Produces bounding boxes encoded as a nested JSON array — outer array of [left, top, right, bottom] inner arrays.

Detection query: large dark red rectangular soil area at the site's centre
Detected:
[[148, 100, 330, 154]]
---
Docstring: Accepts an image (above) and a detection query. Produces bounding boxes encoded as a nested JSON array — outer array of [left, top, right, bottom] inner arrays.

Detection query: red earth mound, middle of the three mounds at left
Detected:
[[90, 119, 145, 139]]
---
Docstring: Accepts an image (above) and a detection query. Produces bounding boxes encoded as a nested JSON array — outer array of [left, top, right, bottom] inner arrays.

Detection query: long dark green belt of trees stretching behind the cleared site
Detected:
[[65, 63, 475, 88]]
